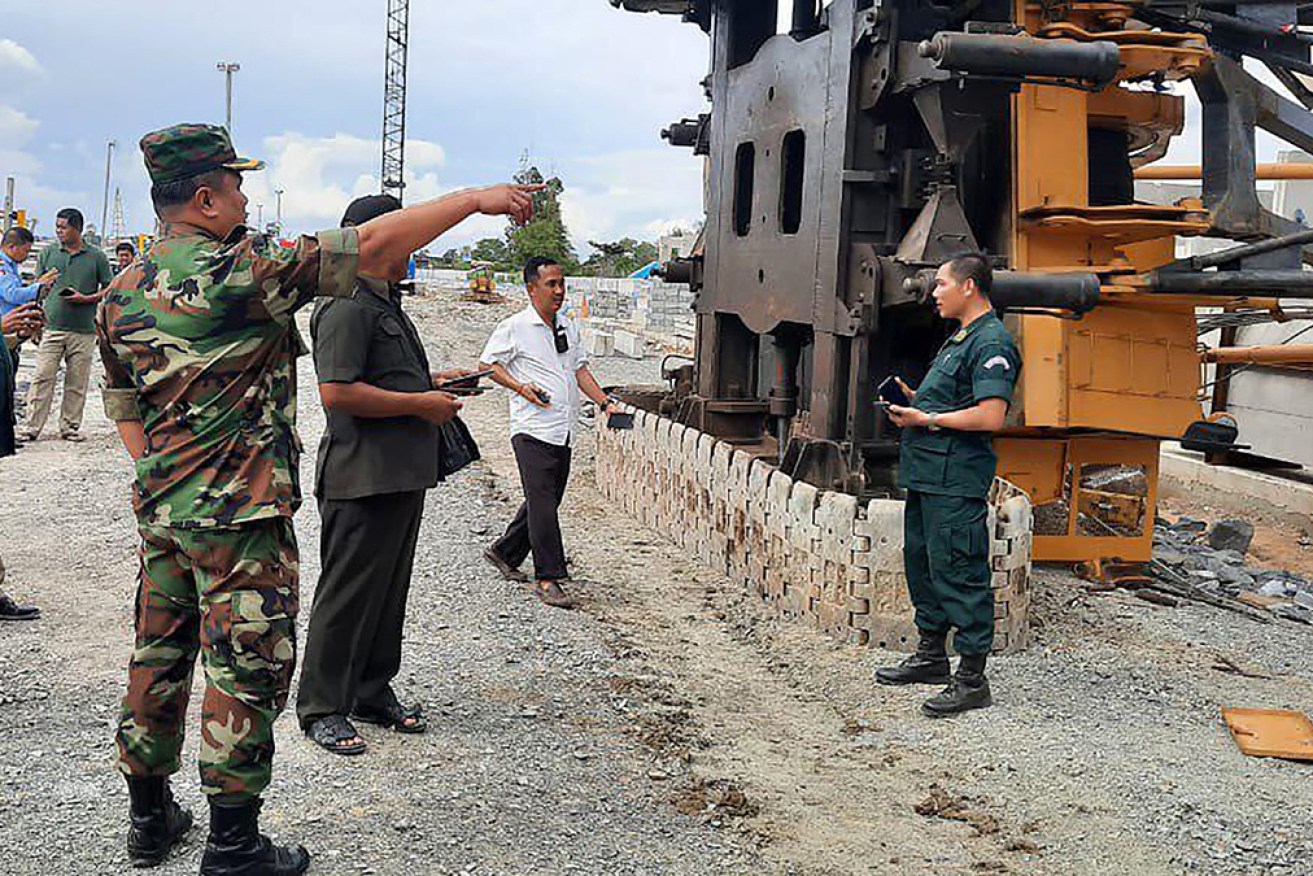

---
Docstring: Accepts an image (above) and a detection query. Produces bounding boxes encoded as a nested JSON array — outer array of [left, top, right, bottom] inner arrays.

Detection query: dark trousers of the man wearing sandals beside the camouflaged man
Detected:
[[297, 490, 424, 729]]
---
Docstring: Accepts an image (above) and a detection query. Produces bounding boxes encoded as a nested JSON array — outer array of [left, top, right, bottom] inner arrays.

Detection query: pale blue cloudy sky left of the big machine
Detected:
[[0, 0, 708, 248]]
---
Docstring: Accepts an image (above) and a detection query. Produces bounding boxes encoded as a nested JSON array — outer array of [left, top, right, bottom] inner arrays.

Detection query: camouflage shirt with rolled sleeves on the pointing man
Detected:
[[96, 225, 358, 529]]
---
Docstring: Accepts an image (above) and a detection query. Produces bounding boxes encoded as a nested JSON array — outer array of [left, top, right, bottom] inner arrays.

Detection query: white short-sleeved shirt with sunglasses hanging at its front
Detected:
[[479, 305, 588, 447]]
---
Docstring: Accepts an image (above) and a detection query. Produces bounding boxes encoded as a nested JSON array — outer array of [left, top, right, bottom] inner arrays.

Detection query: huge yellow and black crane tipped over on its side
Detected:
[[612, 0, 1313, 645]]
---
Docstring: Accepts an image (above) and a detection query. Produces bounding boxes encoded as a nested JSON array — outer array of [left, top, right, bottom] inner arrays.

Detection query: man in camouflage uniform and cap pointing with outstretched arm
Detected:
[[96, 125, 534, 876]]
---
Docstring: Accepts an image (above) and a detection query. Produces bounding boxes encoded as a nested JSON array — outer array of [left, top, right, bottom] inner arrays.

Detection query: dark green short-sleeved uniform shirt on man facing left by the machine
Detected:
[[898, 311, 1022, 499]]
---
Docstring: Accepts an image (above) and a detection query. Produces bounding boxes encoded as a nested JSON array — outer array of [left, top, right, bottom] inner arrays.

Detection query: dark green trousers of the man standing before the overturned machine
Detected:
[[903, 490, 994, 654]]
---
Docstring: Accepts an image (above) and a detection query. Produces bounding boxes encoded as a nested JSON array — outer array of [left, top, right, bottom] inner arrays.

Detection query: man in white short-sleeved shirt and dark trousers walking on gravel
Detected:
[[479, 257, 614, 608]]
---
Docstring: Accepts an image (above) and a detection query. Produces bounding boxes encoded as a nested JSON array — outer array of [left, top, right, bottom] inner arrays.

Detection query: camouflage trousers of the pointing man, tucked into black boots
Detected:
[[117, 517, 299, 802]]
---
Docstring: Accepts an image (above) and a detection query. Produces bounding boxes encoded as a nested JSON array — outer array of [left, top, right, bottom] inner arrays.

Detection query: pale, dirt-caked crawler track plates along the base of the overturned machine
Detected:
[[596, 411, 1031, 651]]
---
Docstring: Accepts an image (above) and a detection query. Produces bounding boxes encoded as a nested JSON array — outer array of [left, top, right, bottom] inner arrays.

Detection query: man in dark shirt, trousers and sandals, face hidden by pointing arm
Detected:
[[297, 194, 469, 755]]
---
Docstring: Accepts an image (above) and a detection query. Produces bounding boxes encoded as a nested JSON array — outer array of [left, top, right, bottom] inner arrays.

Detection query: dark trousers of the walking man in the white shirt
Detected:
[[492, 435, 570, 580]]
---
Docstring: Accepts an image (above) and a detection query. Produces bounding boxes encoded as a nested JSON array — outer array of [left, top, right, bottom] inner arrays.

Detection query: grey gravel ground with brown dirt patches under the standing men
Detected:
[[0, 284, 1313, 876]]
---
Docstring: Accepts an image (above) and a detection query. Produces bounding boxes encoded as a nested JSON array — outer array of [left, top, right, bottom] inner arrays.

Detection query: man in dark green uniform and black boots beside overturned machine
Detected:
[[876, 253, 1022, 717]]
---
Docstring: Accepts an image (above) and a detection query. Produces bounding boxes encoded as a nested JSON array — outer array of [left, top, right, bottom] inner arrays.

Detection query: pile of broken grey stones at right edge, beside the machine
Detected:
[[1153, 517, 1313, 625]]
